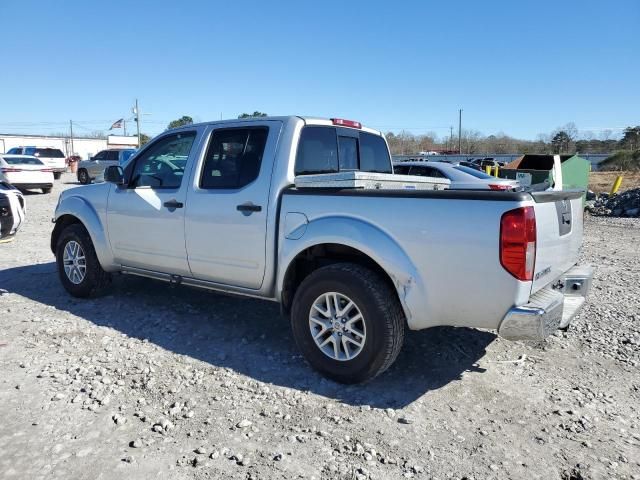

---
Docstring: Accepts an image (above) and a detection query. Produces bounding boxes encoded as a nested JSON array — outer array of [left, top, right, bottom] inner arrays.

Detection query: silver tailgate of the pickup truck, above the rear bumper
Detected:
[[531, 191, 584, 294]]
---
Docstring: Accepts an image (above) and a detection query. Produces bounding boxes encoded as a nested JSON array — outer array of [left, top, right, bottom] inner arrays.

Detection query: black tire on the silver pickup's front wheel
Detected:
[[56, 223, 111, 298]]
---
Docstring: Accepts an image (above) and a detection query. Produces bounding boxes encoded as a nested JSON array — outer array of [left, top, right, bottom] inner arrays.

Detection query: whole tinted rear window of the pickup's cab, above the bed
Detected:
[[295, 125, 392, 175]]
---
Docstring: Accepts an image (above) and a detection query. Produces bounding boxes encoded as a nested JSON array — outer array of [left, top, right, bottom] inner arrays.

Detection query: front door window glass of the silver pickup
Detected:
[[129, 132, 196, 188]]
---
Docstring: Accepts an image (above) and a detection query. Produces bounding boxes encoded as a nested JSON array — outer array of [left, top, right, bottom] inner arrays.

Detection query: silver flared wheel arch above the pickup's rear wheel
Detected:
[[276, 216, 426, 327]]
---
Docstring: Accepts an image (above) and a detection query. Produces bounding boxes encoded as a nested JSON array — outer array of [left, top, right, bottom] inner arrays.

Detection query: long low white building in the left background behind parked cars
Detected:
[[0, 133, 138, 159]]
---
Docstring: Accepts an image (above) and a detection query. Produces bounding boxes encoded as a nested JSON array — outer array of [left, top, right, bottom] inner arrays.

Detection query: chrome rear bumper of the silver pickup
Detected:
[[498, 265, 593, 340]]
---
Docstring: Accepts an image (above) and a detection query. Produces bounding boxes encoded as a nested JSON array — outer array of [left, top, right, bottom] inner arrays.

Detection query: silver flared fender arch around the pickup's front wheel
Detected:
[[52, 195, 117, 271]]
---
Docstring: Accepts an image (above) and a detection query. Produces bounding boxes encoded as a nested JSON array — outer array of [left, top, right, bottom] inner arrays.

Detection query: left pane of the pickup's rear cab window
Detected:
[[295, 127, 339, 175]]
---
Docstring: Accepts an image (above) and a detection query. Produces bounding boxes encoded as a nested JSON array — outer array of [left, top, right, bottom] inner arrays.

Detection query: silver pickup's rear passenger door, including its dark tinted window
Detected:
[[185, 120, 282, 289]]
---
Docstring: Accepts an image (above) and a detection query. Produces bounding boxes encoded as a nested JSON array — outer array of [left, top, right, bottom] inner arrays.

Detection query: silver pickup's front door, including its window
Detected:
[[107, 129, 199, 276]]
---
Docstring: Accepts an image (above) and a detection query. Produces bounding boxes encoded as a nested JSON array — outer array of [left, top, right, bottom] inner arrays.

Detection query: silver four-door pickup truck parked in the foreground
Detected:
[[51, 116, 592, 383]]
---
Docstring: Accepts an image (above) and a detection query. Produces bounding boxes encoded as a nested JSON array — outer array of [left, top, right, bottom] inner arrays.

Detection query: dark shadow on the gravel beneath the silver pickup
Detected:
[[0, 262, 495, 408]]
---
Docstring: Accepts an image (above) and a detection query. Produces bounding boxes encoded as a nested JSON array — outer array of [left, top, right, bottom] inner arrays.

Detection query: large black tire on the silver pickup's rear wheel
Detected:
[[291, 263, 405, 384]]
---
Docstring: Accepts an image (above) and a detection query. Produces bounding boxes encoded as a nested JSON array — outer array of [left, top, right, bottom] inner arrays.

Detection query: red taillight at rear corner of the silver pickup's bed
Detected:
[[500, 207, 536, 282]]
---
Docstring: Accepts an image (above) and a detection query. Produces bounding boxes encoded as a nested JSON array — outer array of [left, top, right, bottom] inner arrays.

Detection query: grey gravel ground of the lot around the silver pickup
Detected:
[[0, 175, 640, 480]]
